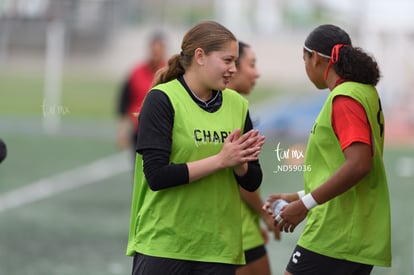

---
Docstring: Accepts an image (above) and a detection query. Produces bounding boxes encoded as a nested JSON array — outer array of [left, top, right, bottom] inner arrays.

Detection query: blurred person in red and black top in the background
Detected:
[[116, 31, 166, 158]]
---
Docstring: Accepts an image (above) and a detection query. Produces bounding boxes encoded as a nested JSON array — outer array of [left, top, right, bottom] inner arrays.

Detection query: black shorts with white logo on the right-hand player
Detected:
[[286, 246, 373, 275]]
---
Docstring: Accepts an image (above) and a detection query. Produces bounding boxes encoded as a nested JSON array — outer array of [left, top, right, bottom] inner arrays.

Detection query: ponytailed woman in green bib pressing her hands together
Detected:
[[127, 21, 264, 275]]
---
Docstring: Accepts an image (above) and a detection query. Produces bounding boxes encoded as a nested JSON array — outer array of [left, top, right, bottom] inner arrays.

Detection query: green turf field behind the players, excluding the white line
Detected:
[[0, 73, 414, 275]]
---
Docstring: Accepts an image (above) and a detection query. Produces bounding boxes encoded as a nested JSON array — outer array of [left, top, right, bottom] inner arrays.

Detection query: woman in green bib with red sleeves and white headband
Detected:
[[264, 25, 391, 275]]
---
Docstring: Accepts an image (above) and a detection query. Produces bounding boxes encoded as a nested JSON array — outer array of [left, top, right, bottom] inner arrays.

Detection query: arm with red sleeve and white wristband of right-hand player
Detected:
[[279, 96, 373, 232]]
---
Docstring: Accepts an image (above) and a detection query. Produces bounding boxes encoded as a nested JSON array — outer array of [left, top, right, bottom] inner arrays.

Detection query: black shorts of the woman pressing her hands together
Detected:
[[132, 253, 237, 275]]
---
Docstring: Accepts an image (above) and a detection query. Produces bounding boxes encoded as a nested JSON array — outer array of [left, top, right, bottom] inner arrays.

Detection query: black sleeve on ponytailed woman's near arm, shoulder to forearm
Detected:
[[137, 90, 189, 191]]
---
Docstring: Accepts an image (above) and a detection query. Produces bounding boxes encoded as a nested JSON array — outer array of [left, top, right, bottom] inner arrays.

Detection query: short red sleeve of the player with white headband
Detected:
[[332, 96, 373, 152]]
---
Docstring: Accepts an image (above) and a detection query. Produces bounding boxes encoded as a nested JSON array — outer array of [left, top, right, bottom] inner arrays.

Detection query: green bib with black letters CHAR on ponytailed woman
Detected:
[[127, 80, 248, 264]]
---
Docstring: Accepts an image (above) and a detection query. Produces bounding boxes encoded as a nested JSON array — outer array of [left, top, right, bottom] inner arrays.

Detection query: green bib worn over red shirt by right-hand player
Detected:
[[298, 82, 391, 266]]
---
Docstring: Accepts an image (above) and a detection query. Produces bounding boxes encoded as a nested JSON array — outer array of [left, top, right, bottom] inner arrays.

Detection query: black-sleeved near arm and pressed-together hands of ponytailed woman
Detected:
[[137, 91, 264, 190]]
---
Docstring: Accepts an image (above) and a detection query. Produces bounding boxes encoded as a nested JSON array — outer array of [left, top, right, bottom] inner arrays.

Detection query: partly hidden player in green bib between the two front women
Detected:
[[227, 41, 280, 275]]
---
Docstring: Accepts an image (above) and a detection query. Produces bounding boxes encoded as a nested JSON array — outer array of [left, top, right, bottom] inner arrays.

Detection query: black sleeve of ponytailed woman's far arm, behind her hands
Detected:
[[235, 113, 263, 192]]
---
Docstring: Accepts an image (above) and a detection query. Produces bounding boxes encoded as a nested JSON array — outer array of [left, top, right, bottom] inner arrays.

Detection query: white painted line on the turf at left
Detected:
[[0, 151, 131, 212]]
